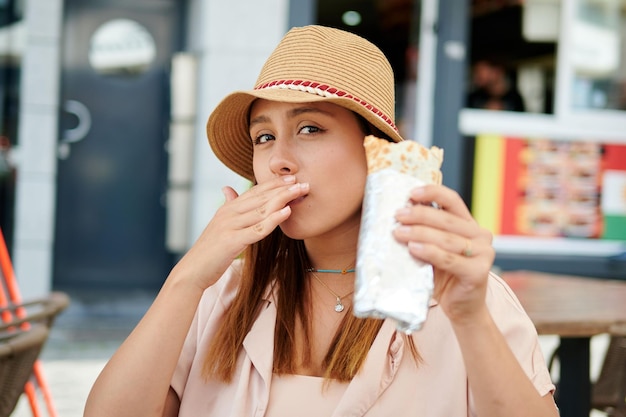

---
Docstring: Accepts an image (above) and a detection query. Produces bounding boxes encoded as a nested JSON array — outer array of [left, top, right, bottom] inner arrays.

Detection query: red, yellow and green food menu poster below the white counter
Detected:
[[472, 135, 626, 240]]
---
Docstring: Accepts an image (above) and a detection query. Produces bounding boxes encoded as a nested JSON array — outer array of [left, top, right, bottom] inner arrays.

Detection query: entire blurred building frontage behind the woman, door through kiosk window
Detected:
[[0, 0, 626, 295]]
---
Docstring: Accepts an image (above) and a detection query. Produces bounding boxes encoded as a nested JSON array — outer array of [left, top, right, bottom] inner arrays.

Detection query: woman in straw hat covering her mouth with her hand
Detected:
[[85, 26, 557, 417]]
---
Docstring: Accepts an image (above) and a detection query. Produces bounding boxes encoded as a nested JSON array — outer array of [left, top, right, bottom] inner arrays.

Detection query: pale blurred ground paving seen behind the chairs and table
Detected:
[[7, 293, 608, 417]]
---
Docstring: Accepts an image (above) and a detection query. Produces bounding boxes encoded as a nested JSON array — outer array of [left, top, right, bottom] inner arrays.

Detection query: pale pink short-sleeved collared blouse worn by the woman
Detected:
[[171, 261, 554, 417]]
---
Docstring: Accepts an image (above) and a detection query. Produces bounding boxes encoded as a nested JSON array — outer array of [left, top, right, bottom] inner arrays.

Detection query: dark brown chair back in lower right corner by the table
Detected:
[[591, 336, 626, 417]]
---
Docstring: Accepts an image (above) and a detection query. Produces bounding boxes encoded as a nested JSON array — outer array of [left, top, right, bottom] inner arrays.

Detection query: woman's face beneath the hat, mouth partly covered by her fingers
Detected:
[[250, 99, 367, 239]]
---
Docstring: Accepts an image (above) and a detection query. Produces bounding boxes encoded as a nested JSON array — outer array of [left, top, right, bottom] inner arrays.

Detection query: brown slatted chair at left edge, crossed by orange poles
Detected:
[[0, 292, 69, 417]]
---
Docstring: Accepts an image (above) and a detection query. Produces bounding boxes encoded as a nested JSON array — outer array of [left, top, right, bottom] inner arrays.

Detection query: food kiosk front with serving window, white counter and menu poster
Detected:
[[459, 0, 626, 279]]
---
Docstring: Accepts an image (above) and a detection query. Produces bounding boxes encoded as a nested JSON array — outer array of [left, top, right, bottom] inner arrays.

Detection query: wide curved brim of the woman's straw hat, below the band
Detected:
[[206, 88, 403, 181]]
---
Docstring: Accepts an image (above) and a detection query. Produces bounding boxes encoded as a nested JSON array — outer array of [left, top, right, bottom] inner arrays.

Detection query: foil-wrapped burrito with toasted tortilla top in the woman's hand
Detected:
[[353, 135, 443, 333]]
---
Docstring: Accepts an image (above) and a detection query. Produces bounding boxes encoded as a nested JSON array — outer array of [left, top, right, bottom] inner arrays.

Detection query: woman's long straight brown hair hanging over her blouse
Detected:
[[203, 228, 392, 382]]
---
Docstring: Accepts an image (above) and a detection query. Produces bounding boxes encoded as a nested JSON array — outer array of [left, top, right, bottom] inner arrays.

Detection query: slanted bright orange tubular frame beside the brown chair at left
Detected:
[[0, 229, 58, 417]]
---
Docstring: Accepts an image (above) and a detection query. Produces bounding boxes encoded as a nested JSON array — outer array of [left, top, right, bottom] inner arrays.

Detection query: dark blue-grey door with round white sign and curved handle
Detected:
[[53, 0, 183, 290]]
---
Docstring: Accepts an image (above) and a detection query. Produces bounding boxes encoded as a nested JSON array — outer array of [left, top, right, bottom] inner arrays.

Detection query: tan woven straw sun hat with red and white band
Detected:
[[207, 26, 402, 180]]
